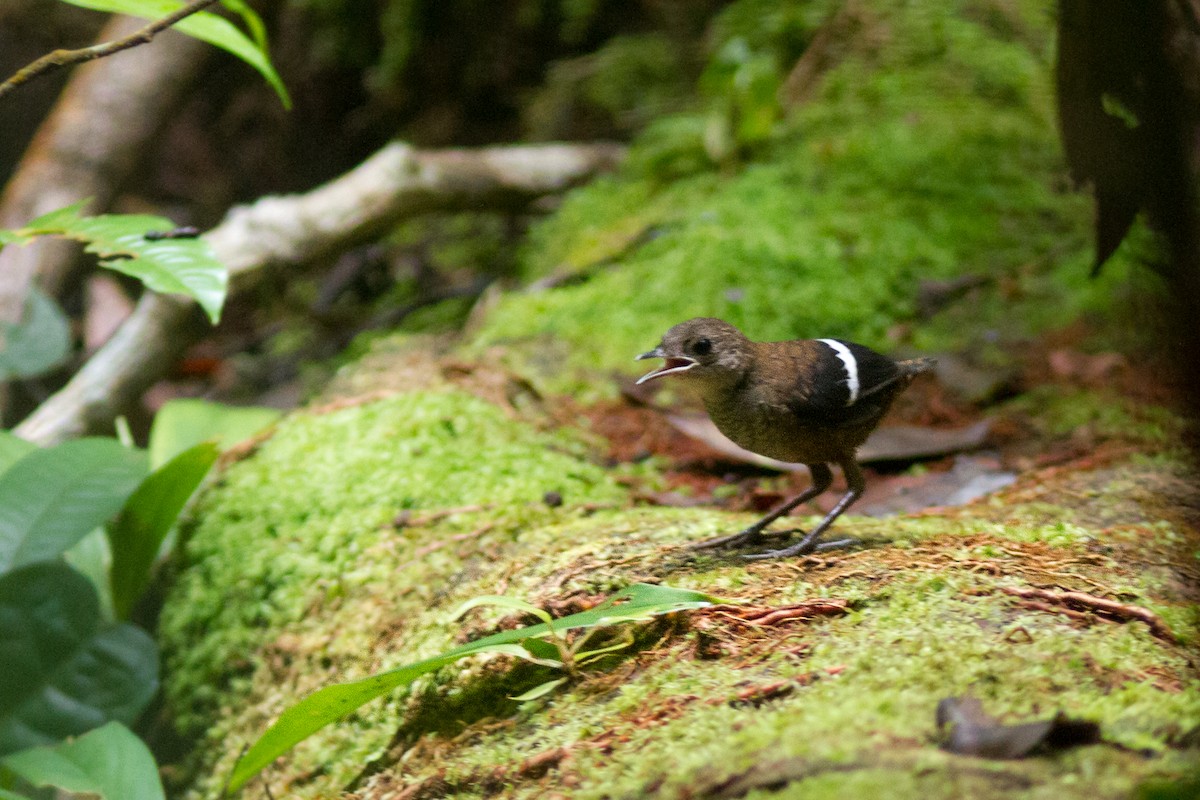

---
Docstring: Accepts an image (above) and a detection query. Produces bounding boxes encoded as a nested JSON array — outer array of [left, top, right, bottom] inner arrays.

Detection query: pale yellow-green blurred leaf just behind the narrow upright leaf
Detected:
[[149, 399, 281, 469]]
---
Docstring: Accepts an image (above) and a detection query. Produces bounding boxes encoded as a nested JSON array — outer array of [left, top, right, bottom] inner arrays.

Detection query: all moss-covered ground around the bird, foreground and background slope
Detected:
[[160, 0, 1200, 800]]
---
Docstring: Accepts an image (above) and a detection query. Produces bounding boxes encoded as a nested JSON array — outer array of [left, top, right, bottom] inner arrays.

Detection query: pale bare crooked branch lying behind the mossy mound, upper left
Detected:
[[14, 143, 624, 445]]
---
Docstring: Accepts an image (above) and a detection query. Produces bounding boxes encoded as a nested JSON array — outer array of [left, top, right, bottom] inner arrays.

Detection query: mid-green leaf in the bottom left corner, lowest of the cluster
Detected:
[[0, 722, 164, 800]]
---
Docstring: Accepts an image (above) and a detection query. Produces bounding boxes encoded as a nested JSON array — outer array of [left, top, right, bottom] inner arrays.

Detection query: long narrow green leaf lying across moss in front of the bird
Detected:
[[229, 583, 721, 792]]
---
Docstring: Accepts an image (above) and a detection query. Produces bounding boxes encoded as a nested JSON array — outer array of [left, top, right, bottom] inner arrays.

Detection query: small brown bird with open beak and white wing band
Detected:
[[637, 317, 934, 559]]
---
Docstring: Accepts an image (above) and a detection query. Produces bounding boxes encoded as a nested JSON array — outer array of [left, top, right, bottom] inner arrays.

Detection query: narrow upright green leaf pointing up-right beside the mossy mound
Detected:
[[107, 441, 218, 619]]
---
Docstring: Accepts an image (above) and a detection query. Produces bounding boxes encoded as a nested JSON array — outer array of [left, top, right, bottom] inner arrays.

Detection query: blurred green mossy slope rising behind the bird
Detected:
[[456, 2, 1142, 400]]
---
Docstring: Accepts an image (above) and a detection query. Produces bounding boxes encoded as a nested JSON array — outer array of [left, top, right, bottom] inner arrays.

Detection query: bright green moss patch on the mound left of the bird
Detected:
[[161, 392, 624, 729]]
